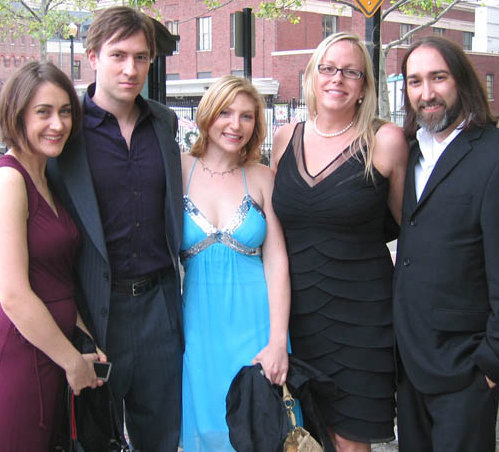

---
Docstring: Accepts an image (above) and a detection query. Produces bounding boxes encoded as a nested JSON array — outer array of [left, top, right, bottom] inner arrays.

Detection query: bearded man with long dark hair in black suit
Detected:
[[393, 36, 499, 452]]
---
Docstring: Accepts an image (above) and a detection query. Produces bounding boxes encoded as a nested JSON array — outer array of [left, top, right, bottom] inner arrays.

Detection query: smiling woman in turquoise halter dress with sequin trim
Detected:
[[181, 76, 290, 452]]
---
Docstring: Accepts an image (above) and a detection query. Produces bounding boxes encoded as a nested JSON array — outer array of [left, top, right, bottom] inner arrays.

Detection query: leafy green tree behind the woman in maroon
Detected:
[[0, 0, 99, 61]]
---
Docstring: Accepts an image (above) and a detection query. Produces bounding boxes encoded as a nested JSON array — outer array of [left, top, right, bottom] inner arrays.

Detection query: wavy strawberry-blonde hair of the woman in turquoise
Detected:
[[191, 75, 267, 165]]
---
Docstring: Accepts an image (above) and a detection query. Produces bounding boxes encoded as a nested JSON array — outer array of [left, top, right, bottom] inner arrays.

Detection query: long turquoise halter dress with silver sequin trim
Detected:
[[180, 160, 270, 452]]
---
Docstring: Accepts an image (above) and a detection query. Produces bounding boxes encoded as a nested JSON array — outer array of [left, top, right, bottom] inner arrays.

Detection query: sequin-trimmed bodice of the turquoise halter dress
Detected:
[[180, 162, 267, 262]]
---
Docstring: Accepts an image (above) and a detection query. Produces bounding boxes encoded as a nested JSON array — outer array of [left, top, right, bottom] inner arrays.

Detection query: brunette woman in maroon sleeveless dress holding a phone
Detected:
[[0, 62, 105, 452]]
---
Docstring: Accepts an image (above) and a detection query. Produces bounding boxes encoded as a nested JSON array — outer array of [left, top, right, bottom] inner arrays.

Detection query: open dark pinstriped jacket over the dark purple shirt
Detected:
[[47, 101, 183, 349]]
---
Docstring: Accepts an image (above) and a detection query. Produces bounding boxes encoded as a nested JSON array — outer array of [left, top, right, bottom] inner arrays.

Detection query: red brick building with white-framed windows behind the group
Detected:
[[160, 0, 499, 113]]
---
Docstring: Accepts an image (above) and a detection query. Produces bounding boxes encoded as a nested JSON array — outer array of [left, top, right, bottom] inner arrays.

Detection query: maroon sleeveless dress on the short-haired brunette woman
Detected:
[[0, 155, 79, 452]]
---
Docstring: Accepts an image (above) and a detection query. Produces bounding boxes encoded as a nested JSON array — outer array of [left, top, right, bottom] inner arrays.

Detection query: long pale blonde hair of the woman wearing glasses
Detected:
[[303, 32, 377, 177]]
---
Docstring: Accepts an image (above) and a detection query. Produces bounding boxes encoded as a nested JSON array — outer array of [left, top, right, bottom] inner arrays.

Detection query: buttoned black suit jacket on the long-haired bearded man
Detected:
[[393, 126, 499, 394]]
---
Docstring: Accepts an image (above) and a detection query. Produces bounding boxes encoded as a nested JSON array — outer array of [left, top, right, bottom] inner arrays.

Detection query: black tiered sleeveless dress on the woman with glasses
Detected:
[[272, 123, 395, 442]]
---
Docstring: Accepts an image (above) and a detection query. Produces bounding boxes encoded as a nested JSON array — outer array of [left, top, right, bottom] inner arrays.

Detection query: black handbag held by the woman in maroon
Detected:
[[54, 328, 130, 452]]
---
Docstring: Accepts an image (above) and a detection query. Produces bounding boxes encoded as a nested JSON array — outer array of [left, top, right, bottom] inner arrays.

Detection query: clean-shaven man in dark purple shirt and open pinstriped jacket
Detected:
[[49, 7, 183, 452]]
